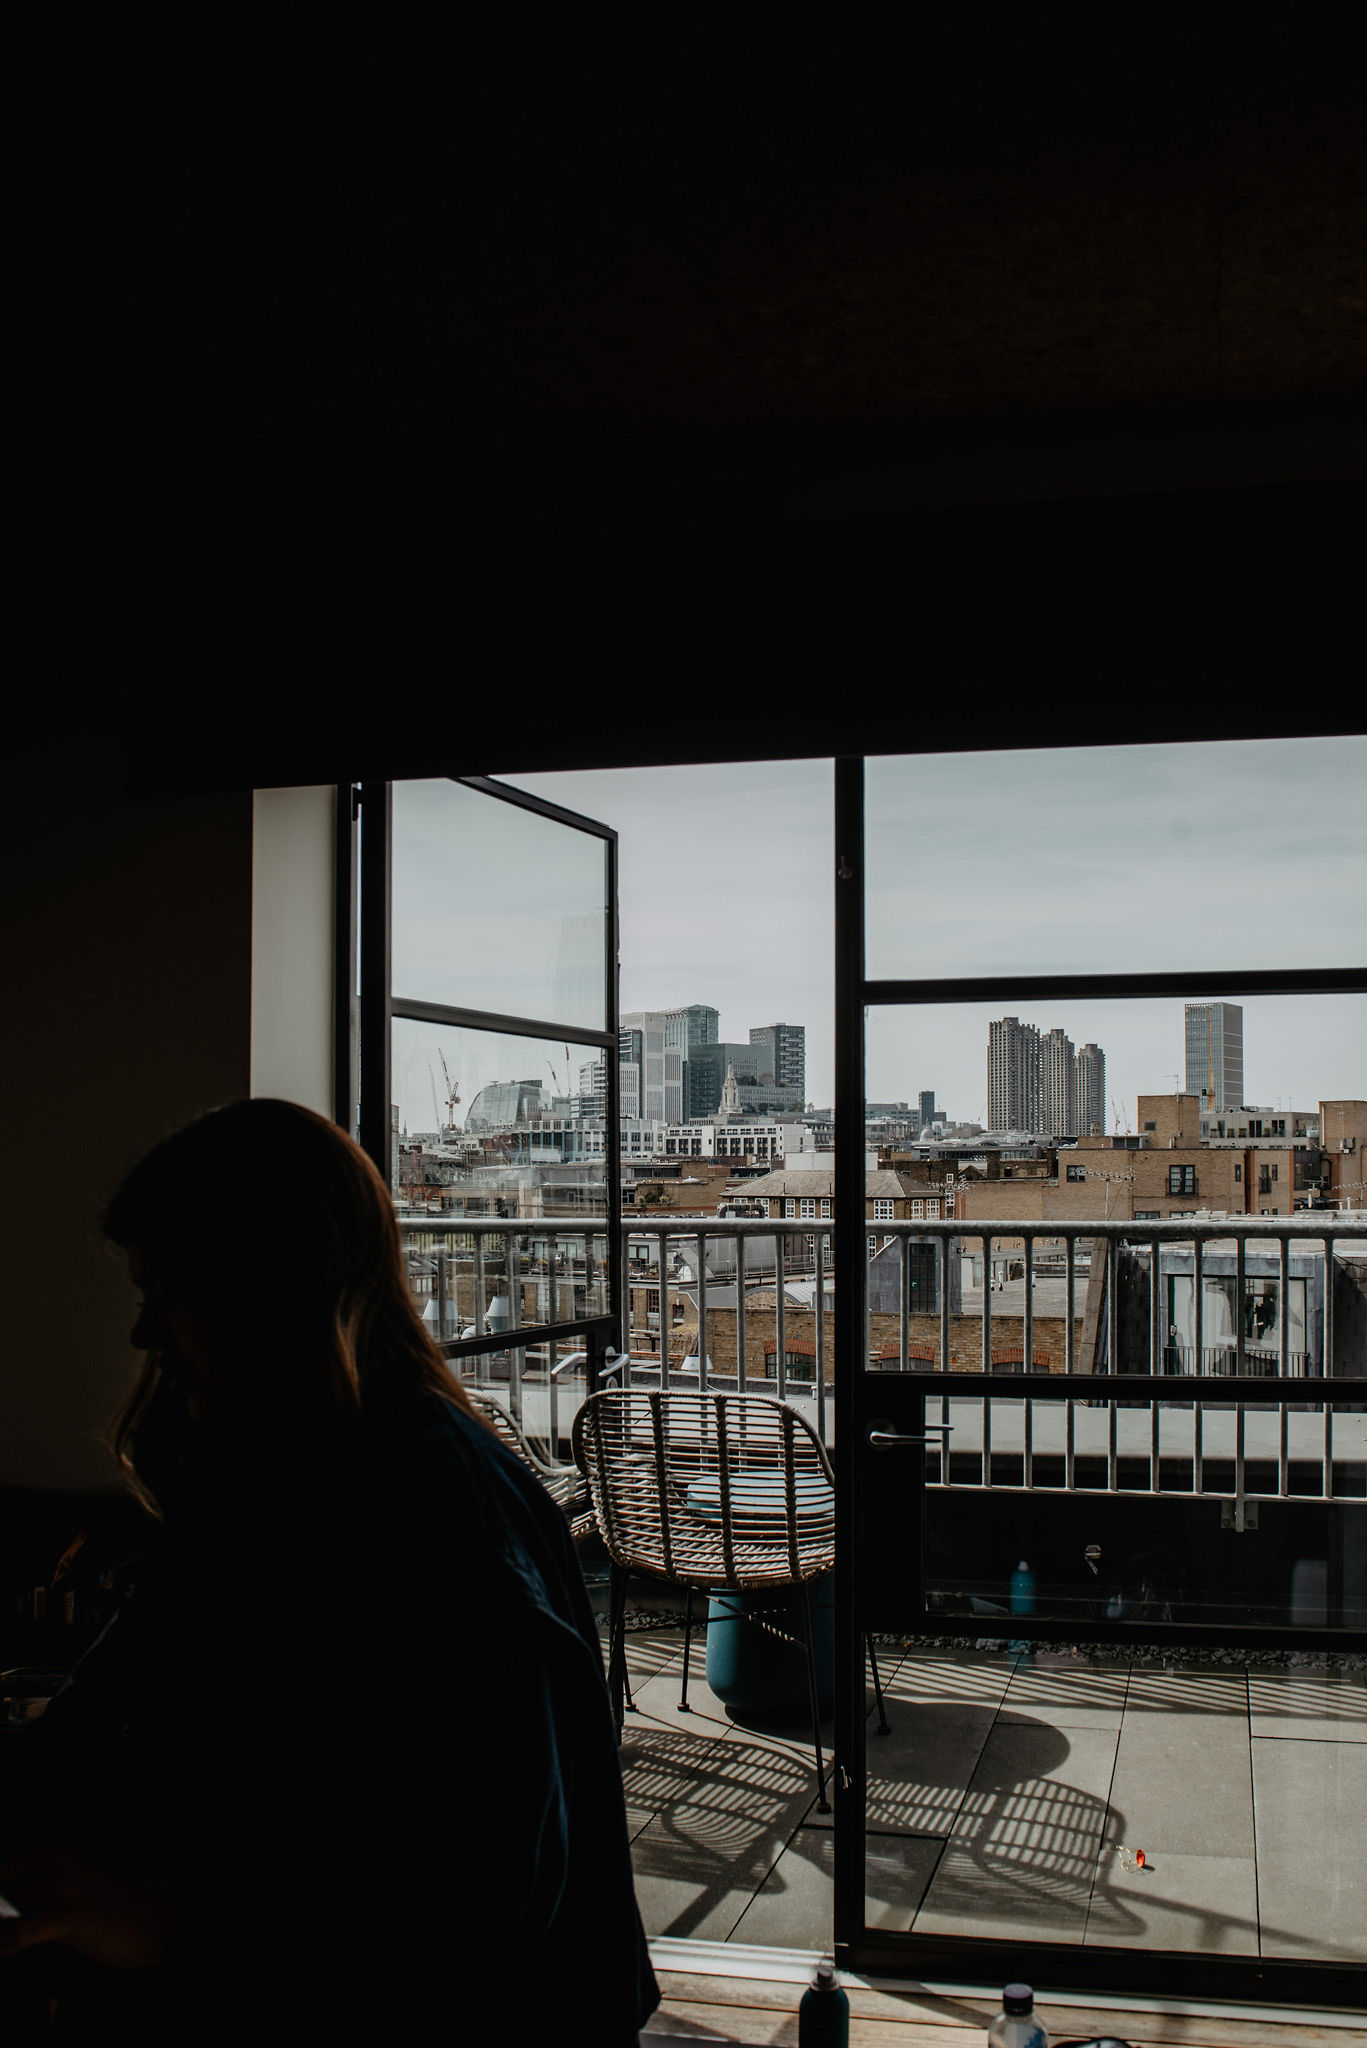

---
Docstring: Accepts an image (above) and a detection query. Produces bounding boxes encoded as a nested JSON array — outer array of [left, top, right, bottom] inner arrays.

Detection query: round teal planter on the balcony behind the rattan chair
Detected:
[[707, 1571, 836, 1720]]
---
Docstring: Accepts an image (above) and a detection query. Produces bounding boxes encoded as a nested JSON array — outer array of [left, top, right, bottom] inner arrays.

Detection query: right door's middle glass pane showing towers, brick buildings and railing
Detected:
[[865, 995, 1367, 1378]]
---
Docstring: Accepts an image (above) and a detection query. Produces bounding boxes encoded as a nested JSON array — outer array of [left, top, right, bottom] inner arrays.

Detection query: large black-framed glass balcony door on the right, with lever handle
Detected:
[[834, 741, 1367, 2007]]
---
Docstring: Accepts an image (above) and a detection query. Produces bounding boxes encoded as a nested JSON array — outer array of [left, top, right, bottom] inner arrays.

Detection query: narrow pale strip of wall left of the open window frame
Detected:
[[252, 784, 336, 1116]]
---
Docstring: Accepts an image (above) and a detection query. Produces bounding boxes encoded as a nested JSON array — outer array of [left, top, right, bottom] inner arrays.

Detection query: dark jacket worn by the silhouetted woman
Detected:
[[6, 1395, 658, 2044]]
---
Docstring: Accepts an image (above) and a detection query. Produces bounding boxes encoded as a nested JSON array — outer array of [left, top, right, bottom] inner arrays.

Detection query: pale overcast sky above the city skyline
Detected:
[[396, 737, 1367, 1128]]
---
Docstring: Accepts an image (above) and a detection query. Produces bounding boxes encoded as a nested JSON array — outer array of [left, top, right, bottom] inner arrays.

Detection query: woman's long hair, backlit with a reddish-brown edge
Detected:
[[105, 1096, 473, 1520]]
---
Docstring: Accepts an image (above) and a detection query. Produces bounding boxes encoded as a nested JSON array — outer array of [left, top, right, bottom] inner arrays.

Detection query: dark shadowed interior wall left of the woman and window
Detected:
[[0, 674, 252, 1489]]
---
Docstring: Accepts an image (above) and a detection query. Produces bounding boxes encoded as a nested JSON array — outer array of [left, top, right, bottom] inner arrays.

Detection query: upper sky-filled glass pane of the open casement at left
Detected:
[[391, 780, 609, 1030]]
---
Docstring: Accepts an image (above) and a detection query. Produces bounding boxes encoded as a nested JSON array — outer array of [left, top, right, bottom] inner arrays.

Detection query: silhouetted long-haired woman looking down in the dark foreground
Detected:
[[0, 1100, 658, 2044]]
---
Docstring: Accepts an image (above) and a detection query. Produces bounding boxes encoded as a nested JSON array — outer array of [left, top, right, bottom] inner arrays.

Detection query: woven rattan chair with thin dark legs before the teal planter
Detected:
[[572, 1389, 887, 1812]]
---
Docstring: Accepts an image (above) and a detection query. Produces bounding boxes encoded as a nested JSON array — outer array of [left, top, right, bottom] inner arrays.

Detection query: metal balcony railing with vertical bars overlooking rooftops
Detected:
[[402, 1212, 1367, 1499]]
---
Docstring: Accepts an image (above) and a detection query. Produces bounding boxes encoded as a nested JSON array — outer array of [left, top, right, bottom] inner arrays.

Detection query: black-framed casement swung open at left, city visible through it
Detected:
[[357, 776, 621, 1376]]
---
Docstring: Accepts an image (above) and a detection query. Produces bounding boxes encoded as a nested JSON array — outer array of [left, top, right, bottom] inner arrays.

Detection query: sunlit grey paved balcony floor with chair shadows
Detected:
[[621, 1616, 1367, 1962]]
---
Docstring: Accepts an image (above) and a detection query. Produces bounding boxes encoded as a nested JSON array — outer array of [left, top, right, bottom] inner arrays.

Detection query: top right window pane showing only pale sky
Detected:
[[865, 737, 1367, 981]]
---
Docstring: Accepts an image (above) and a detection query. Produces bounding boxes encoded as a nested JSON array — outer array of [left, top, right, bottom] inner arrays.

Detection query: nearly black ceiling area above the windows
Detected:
[[12, 6, 1367, 780]]
